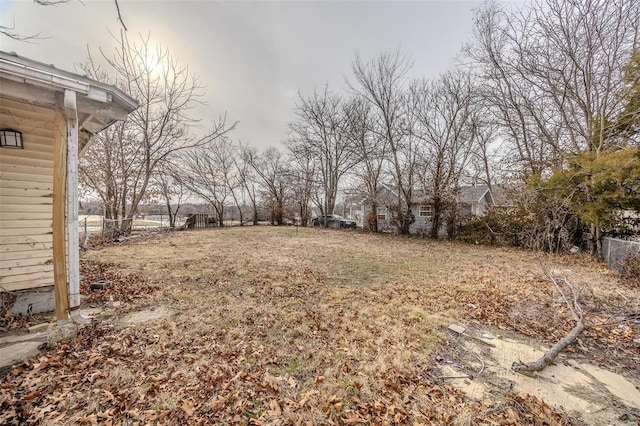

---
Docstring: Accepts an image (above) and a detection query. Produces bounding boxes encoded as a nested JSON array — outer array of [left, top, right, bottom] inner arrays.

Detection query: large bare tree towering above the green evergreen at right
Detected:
[[467, 0, 640, 253]]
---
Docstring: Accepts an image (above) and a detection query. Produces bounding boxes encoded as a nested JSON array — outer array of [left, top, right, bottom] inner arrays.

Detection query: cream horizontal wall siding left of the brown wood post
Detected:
[[0, 98, 54, 291]]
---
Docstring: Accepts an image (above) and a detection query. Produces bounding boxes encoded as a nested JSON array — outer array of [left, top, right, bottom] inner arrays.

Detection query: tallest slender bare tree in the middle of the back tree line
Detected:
[[349, 51, 417, 234]]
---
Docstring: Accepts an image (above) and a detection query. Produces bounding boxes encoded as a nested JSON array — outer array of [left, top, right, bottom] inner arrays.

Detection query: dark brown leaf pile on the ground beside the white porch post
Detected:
[[80, 260, 159, 304]]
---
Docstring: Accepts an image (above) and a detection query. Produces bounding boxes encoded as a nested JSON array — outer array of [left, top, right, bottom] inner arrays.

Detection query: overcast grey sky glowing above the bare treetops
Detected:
[[0, 0, 488, 148]]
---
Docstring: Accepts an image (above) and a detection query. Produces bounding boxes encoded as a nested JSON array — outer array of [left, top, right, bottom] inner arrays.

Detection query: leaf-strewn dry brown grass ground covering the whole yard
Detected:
[[0, 227, 640, 425]]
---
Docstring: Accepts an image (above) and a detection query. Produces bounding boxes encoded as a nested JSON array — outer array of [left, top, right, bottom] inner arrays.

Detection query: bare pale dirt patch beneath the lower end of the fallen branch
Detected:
[[440, 329, 640, 425]]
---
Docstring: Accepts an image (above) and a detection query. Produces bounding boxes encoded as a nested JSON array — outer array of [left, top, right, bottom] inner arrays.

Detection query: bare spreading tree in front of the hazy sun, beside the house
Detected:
[[82, 33, 236, 233]]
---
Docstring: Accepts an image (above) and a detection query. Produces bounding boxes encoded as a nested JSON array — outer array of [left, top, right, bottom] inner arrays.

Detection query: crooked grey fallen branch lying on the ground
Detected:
[[511, 272, 584, 372]]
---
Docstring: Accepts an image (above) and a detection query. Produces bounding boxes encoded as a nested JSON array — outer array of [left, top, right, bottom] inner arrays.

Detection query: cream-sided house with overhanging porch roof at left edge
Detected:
[[0, 52, 138, 321]]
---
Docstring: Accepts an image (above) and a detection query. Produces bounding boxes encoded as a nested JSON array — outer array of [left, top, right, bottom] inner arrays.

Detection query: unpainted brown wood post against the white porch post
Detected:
[[53, 96, 69, 325]]
